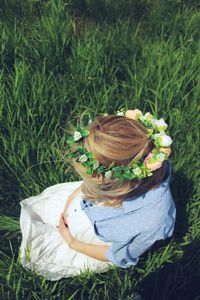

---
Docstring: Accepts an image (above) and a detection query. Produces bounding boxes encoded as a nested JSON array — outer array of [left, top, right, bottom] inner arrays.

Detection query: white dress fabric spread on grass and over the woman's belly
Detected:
[[19, 181, 113, 280]]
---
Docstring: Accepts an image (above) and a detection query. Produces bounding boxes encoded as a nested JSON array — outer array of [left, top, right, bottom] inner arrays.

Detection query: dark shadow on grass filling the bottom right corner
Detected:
[[139, 240, 200, 300]]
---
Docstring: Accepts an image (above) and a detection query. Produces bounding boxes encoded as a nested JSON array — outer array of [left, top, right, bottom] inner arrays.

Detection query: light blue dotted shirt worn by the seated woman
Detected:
[[80, 160, 176, 268]]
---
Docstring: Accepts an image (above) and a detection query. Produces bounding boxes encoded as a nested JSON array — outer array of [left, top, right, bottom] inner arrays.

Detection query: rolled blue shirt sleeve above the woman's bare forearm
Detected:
[[106, 228, 162, 269]]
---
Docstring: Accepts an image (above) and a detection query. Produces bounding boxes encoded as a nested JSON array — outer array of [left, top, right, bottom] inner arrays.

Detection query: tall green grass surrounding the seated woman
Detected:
[[0, 0, 200, 300]]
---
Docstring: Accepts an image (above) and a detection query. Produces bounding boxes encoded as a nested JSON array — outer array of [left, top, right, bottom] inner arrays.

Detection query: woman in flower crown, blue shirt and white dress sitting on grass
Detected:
[[20, 109, 176, 280]]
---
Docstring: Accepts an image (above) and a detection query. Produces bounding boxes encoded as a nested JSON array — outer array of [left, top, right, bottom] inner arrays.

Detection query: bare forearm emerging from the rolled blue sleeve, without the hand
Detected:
[[69, 239, 109, 261]]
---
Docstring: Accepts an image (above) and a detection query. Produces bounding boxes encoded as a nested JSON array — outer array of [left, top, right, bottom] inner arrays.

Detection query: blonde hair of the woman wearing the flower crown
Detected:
[[66, 115, 166, 207]]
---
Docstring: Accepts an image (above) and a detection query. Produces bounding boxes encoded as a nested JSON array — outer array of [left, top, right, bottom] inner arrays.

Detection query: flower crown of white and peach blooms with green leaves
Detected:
[[67, 109, 172, 181]]
